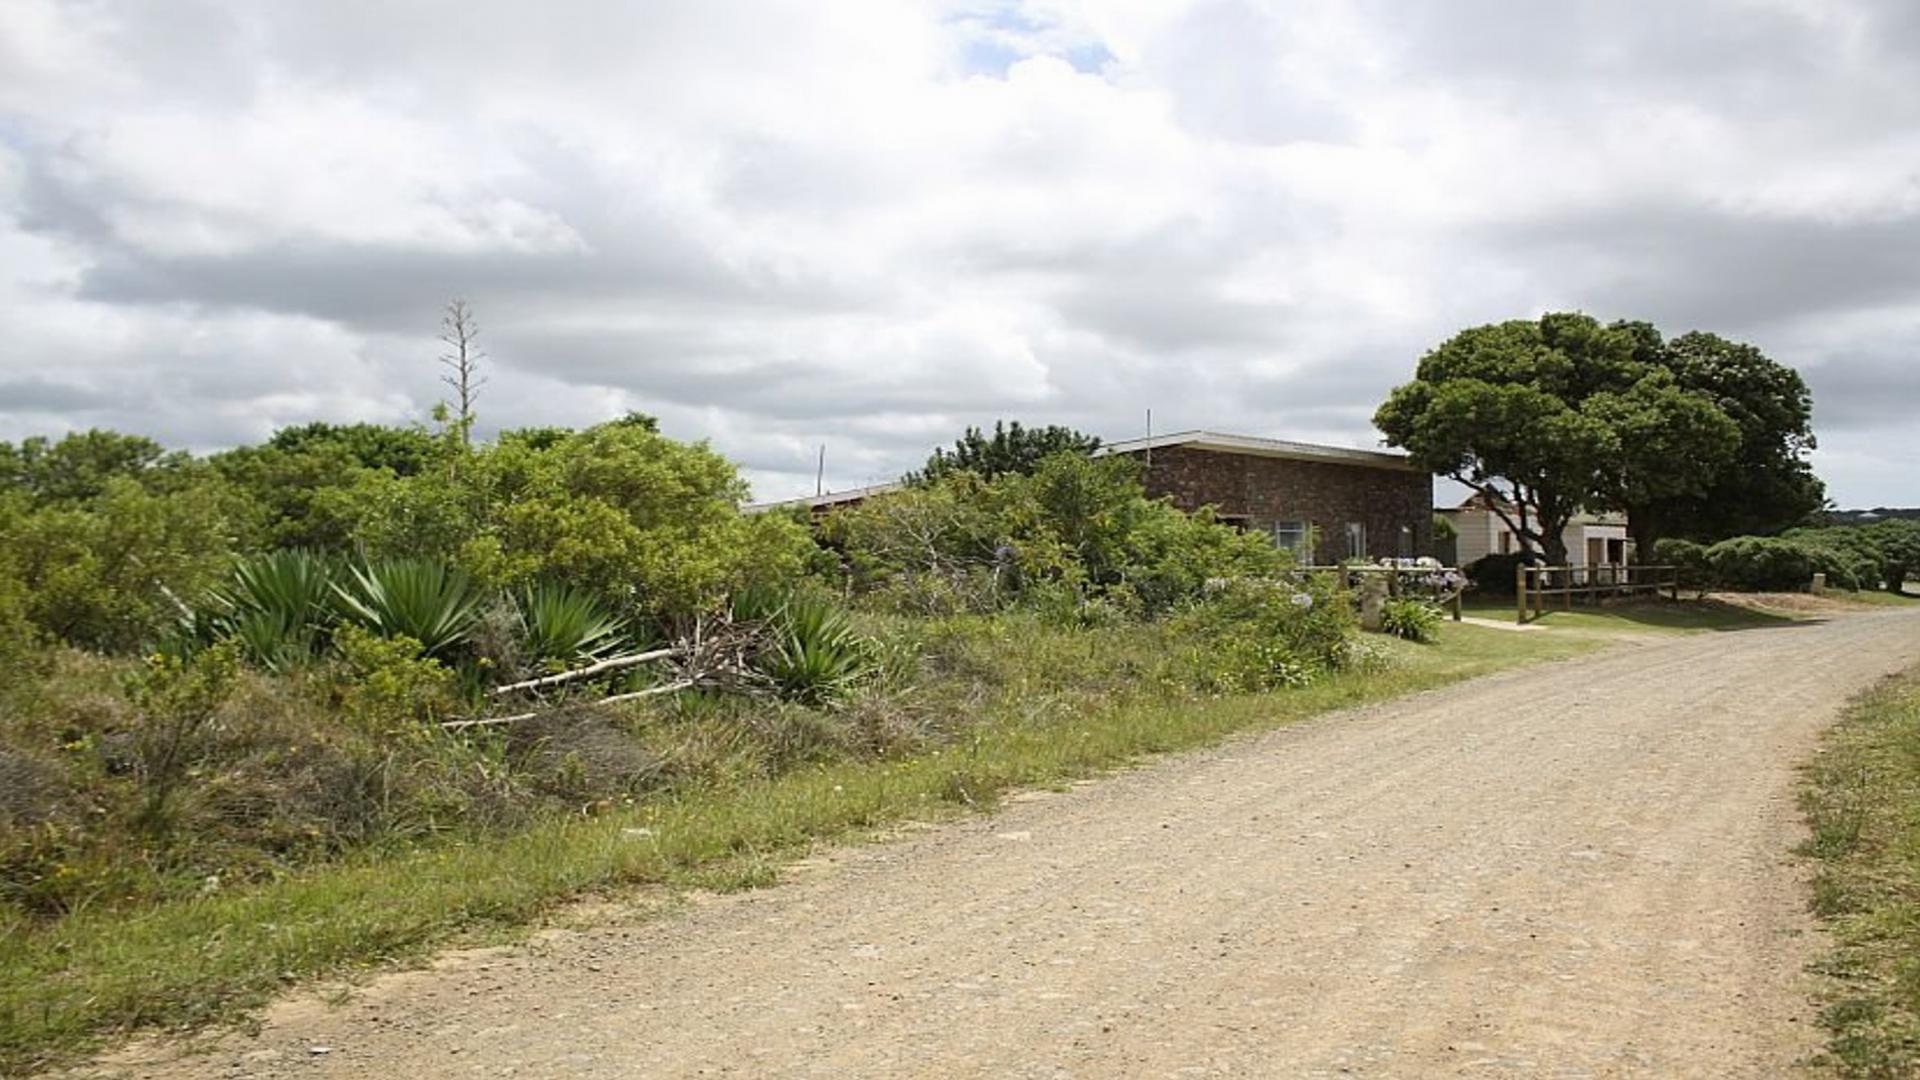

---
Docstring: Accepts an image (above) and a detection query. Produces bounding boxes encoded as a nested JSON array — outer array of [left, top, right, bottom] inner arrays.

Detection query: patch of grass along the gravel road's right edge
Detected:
[[1803, 669, 1920, 1076]]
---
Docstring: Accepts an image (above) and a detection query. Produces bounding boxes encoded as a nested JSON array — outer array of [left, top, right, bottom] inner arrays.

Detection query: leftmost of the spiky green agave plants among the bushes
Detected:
[[209, 550, 334, 671]]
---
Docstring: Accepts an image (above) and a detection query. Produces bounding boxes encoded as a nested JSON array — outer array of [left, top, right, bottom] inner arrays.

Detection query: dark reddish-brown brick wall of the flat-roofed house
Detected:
[[1135, 446, 1432, 565]]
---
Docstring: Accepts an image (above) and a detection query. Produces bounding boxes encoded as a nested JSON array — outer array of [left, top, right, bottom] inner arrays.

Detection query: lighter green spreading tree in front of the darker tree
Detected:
[[1375, 313, 1740, 565]]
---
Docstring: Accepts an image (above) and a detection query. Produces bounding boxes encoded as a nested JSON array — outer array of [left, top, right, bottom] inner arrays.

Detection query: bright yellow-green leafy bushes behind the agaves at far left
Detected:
[[0, 417, 816, 665]]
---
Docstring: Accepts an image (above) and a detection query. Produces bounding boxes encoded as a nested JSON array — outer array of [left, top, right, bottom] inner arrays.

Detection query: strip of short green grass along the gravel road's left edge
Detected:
[[0, 626, 1594, 1072]]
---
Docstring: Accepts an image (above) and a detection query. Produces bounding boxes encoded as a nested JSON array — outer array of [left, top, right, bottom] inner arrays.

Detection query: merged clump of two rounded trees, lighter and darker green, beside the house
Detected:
[[1375, 313, 1822, 563]]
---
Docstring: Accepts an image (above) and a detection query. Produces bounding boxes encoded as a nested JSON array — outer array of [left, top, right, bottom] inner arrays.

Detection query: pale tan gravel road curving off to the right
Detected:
[[97, 613, 1920, 1078]]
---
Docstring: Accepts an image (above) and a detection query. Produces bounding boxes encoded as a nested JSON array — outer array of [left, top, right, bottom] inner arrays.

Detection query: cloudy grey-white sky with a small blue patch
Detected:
[[0, 0, 1920, 505]]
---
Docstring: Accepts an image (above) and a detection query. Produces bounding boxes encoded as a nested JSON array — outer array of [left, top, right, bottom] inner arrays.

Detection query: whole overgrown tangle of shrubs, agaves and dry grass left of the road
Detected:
[[0, 419, 1382, 937]]
